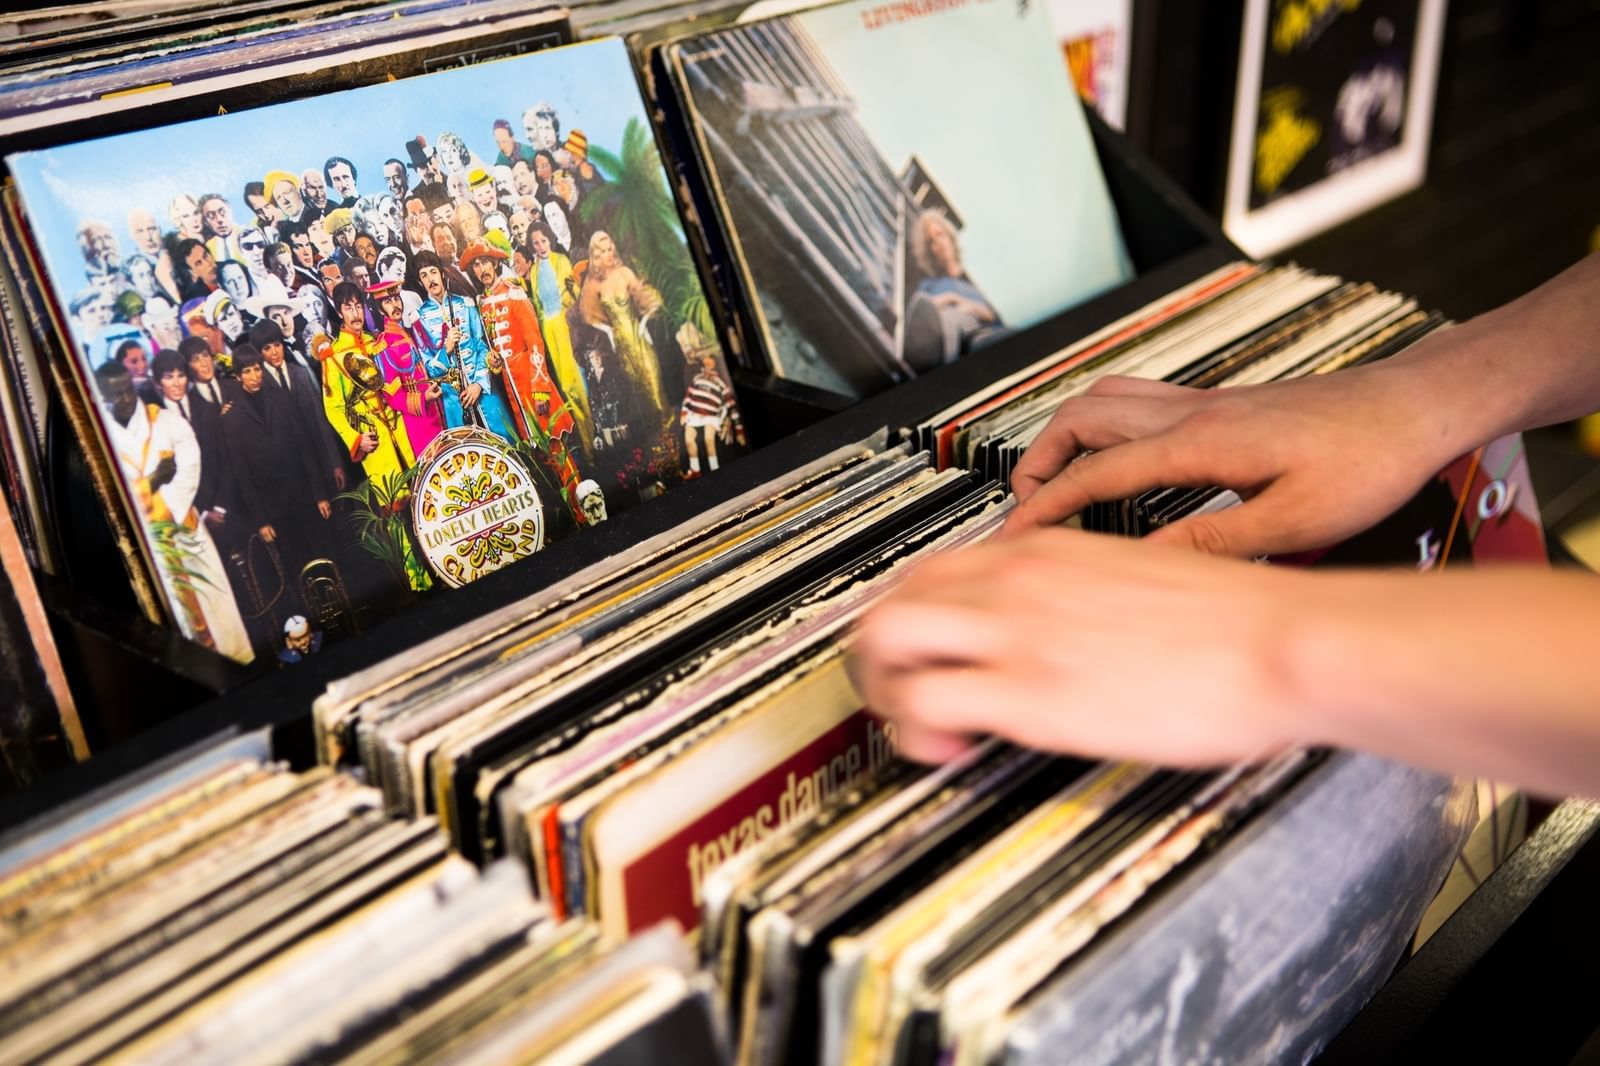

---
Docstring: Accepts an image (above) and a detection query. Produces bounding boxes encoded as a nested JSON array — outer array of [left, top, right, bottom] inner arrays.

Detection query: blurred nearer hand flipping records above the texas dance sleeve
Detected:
[[851, 530, 1320, 765]]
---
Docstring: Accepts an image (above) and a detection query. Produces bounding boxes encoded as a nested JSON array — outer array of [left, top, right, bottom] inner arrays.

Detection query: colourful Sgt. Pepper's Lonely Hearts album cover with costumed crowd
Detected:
[[6, 40, 744, 661]]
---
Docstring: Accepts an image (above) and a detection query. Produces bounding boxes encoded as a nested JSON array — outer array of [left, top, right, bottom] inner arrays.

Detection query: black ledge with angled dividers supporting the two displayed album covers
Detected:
[[15, 101, 1243, 806]]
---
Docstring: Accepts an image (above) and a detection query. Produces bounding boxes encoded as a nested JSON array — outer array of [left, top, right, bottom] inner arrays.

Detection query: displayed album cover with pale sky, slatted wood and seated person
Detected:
[[669, 0, 1131, 395]]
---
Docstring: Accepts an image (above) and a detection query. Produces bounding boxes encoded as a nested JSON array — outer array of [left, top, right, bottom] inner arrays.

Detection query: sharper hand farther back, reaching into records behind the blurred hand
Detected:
[[1005, 365, 1472, 557]]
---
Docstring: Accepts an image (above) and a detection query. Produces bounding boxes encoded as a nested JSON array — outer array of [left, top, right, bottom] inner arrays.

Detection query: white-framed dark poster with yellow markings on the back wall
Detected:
[[1222, 0, 1445, 256]]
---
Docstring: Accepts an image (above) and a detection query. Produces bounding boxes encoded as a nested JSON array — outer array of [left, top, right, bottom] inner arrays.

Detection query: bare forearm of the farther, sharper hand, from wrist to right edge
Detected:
[[1355, 254, 1600, 455]]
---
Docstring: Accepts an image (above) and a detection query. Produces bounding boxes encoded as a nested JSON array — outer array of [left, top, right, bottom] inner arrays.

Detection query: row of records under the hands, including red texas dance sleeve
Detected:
[[297, 251, 1440, 1063]]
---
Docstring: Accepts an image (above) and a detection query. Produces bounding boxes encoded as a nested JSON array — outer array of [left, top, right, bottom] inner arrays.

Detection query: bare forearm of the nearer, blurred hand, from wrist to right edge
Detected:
[[1285, 568, 1600, 795]]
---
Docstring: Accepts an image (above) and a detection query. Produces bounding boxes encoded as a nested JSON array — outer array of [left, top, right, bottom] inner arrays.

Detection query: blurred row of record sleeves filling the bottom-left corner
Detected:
[[0, 738, 720, 1063]]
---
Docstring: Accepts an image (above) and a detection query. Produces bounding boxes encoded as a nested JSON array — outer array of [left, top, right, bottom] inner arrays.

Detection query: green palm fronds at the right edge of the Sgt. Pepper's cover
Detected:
[[571, 118, 717, 336]]
